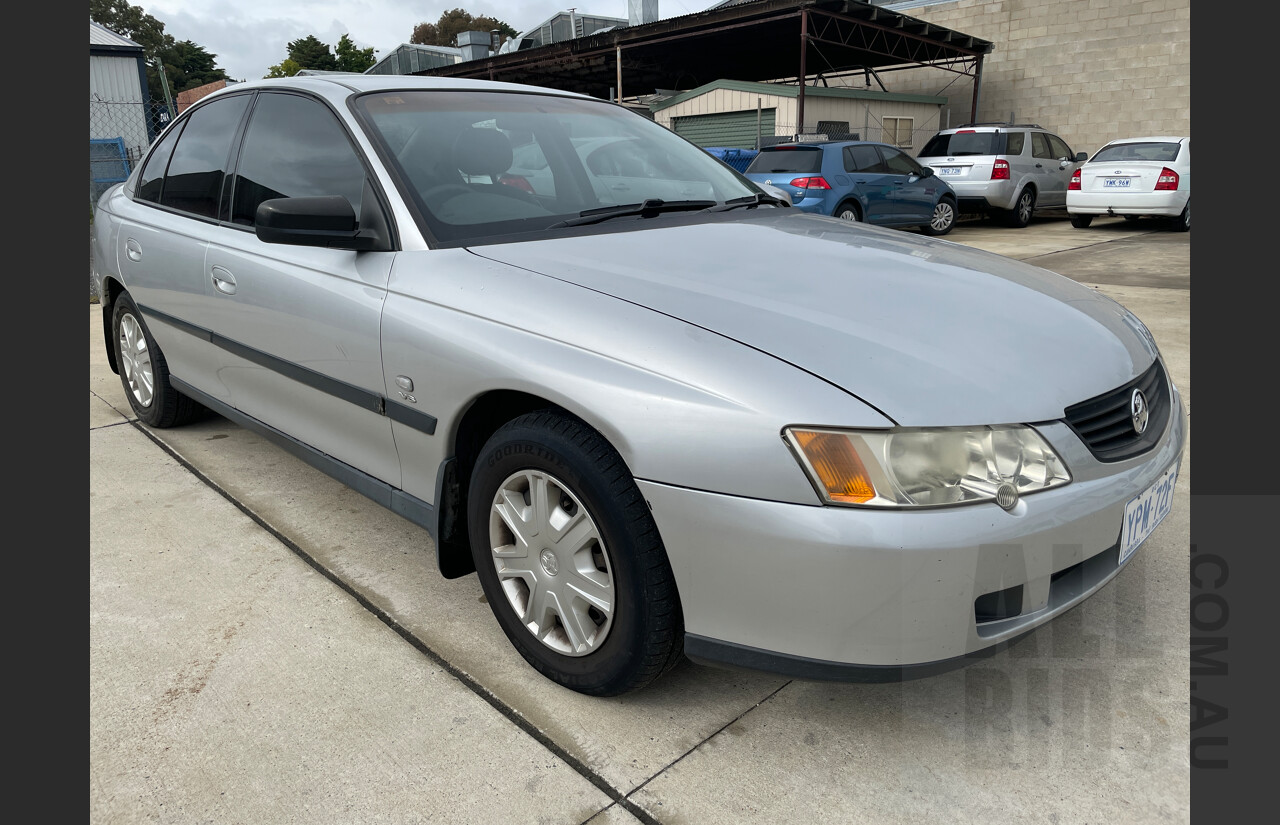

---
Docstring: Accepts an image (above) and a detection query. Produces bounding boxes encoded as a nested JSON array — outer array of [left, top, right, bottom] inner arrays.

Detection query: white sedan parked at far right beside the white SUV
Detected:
[[1066, 137, 1192, 232]]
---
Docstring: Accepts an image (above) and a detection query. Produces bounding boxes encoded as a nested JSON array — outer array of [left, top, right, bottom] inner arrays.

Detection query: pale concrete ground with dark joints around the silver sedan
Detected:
[[90, 213, 1190, 825]]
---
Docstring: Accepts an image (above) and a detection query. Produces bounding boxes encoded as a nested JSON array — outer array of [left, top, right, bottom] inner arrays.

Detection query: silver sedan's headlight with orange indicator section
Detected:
[[782, 425, 1071, 509]]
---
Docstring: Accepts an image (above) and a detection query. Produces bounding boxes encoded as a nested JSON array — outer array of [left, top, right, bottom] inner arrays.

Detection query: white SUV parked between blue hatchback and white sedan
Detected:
[[919, 123, 1088, 228]]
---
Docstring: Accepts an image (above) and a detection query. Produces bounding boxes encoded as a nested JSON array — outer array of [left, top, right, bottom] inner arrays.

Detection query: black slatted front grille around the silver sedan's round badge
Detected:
[[1066, 358, 1171, 462]]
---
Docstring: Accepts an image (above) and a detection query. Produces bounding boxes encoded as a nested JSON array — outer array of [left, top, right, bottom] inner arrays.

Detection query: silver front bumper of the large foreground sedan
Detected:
[[639, 390, 1185, 680]]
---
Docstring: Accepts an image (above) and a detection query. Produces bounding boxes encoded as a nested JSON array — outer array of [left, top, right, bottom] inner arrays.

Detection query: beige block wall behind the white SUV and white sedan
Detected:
[[858, 0, 1192, 153]]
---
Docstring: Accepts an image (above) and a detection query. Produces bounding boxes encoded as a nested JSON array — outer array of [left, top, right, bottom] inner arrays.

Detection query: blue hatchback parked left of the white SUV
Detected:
[[744, 141, 956, 235]]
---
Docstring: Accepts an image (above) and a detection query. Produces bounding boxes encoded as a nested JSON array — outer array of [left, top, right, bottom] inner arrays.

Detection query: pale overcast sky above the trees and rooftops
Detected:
[[133, 0, 718, 81]]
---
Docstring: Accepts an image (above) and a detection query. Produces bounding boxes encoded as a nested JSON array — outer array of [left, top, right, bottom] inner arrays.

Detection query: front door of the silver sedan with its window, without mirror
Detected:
[[204, 92, 401, 487]]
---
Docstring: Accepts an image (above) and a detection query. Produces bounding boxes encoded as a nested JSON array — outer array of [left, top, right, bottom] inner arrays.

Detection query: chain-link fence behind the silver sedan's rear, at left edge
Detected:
[[88, 97, 172, 216]]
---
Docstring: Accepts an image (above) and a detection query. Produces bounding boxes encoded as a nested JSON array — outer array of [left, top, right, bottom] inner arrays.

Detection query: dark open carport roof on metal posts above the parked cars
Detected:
[[417, 0, 992, 97]]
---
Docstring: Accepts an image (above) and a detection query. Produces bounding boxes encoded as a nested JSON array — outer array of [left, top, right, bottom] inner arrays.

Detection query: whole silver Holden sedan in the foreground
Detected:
[[93, 75, 1184, 696]]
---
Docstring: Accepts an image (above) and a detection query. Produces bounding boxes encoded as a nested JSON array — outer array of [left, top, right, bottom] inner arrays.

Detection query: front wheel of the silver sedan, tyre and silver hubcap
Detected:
[[467, 409, 685, 696]]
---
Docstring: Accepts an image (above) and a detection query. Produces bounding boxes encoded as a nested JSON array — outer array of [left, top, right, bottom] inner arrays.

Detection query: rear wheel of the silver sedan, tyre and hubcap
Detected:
[[111, 292, 201, 428]]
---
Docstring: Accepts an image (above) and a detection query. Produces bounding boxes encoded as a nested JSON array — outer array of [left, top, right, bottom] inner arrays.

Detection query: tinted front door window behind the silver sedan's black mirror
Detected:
[[232, 93, 365, 226]]
